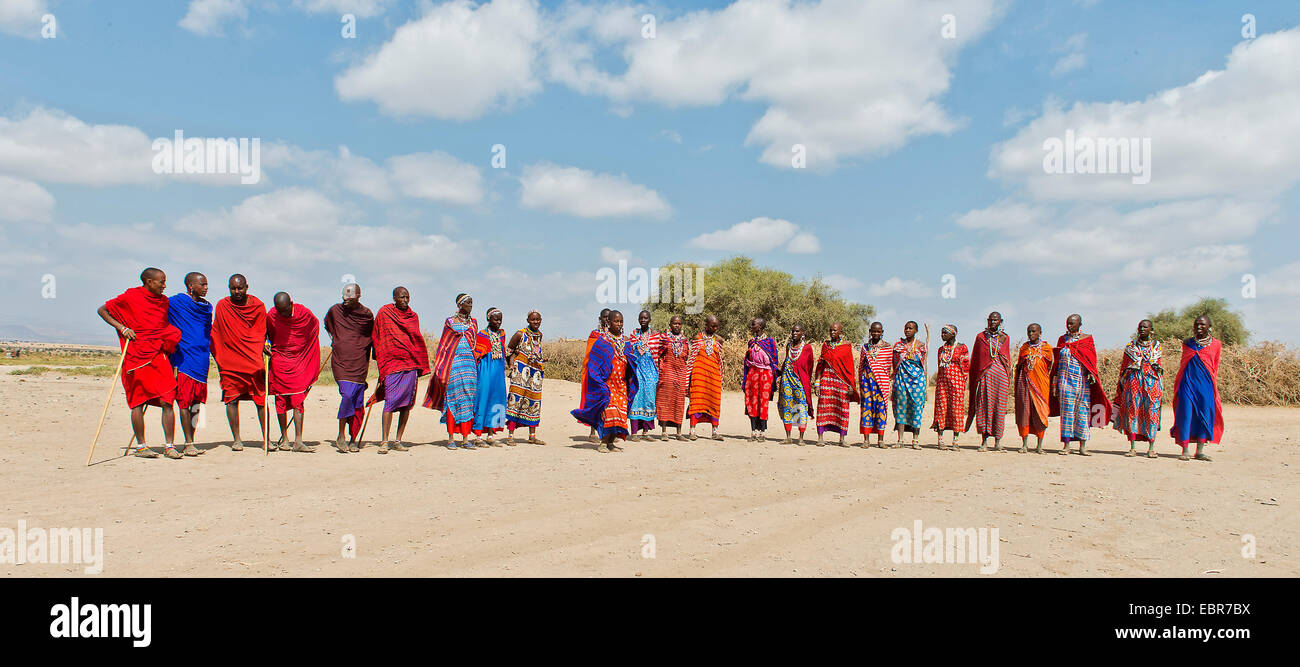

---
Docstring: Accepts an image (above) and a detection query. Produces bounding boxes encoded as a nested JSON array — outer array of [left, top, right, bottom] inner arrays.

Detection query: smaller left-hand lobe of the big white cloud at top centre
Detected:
[[334, 0, 541, 121]]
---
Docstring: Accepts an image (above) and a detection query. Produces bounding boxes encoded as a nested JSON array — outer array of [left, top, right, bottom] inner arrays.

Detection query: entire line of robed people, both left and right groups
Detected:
[[99, 268, 1223, 460]]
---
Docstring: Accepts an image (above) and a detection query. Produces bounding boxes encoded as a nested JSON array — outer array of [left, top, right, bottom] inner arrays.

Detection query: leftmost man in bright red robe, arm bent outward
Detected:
[[98, 267, 182, 459]]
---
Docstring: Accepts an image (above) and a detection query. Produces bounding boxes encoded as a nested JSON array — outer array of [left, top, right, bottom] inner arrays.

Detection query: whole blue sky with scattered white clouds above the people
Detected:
[[0, 0, 1300, 346]]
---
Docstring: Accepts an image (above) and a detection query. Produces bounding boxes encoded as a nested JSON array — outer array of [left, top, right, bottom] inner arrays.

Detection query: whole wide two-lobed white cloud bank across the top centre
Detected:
[[334, 0, 1004, 168]]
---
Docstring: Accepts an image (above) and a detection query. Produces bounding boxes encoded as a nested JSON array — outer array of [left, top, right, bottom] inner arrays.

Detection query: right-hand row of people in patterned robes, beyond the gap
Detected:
[[572, 309, 1223, 462]]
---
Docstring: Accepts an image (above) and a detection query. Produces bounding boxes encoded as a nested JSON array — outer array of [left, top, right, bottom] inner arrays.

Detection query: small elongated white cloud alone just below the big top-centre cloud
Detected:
[[519, 163, 672, 220]]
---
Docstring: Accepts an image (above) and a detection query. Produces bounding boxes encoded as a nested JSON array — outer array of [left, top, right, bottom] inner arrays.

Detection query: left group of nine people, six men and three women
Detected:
[[98, 268, 543, 459]]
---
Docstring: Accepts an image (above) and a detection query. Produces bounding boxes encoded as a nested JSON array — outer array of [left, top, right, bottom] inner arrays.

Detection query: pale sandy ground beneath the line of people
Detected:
[[0, 374, 1300, 577]]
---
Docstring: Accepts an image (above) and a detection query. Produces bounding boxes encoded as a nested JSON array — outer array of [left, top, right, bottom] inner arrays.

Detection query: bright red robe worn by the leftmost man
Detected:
[[104, 285, 181, 408]]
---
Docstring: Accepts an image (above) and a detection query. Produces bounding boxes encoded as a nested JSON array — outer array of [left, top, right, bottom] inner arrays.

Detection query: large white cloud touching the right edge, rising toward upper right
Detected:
[[989, 29, 1300, 200]]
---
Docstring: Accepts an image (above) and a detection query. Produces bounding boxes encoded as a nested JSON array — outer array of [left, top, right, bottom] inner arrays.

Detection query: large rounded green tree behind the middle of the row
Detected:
[[644, 256, 876, 341]]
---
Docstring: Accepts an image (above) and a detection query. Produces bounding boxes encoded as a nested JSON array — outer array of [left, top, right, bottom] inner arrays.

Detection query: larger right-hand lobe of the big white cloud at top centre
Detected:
[[543, 0, 1002, 168]]
